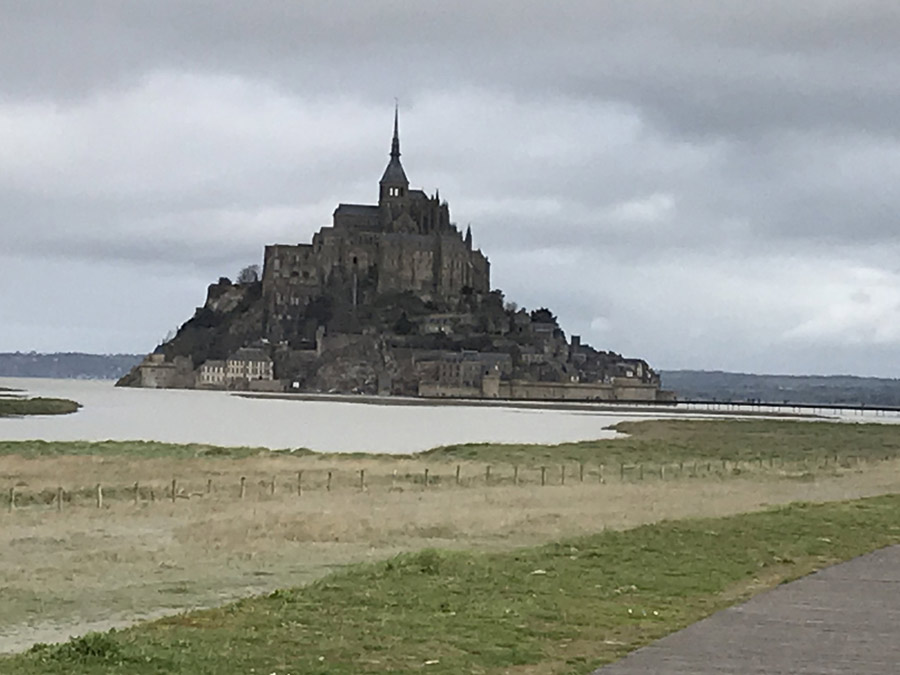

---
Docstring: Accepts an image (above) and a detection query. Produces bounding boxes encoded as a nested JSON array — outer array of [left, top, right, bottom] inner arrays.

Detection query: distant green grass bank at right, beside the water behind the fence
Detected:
[[423, 420, 900, 465]]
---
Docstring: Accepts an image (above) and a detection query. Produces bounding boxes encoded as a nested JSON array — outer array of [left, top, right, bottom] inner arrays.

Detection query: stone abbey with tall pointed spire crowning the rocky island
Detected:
[[262, 109, 491, 341]]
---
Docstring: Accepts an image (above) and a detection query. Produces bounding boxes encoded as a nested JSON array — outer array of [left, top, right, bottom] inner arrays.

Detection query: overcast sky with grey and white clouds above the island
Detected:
[[0, 0, 900, 377]]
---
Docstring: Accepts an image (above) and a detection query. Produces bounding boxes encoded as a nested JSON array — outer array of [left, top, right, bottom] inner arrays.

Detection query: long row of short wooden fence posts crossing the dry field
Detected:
[[0, 455, 896, 512]]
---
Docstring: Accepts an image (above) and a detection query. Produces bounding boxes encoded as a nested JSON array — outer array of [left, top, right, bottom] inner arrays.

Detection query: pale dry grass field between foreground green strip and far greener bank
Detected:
[[0, 446, 900, 650]]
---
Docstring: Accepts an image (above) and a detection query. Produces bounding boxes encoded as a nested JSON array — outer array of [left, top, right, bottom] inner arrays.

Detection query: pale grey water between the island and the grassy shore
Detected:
[[0, 378, 652, 453]]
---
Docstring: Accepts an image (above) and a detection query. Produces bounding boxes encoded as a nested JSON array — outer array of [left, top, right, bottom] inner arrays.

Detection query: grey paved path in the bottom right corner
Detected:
[[595, 546, 900, 675]]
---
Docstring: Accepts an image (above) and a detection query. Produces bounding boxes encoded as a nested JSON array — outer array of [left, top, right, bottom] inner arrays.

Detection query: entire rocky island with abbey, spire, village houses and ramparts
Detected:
[[119, 111, 671, 402]]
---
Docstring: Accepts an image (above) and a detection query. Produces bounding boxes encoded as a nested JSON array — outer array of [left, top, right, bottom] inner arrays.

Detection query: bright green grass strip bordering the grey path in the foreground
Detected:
[[7, 496, 900, 675]]
